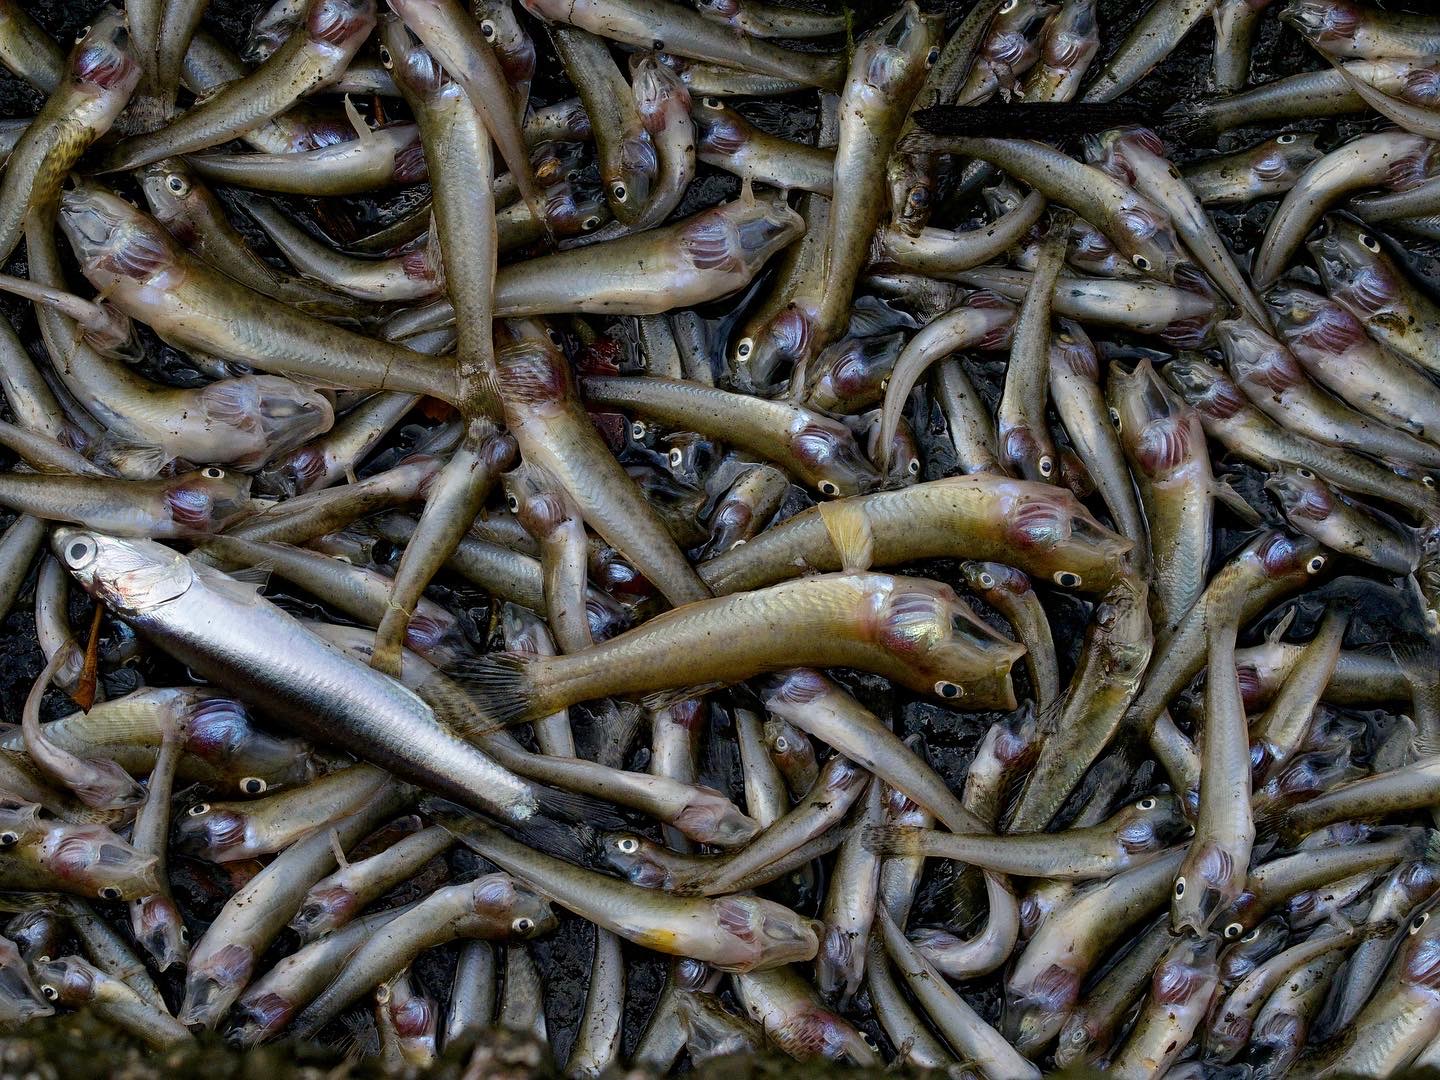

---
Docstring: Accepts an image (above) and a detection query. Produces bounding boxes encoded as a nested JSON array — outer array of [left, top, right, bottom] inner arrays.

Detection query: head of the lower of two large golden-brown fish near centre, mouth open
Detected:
[[876, 577, 1025, 710]]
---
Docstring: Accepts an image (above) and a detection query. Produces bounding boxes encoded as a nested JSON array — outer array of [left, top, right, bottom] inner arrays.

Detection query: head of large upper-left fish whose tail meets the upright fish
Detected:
[[59, 183, 177, 288]]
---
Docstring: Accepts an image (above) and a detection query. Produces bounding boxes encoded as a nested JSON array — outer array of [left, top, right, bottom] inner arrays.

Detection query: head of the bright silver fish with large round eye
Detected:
[[50, 527, 194, 618]]
